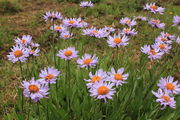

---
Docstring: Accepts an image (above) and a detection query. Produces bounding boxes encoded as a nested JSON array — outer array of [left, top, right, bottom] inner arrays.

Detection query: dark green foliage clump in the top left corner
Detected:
[[0, 0, 21, 14]]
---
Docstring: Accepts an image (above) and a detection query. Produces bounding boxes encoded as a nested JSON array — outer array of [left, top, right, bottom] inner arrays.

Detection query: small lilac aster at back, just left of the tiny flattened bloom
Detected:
[[120, 17, 136, 27]]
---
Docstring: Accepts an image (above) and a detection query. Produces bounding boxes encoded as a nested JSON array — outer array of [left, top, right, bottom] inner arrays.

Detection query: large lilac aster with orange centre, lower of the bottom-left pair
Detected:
[[22, 78, 49, 102]]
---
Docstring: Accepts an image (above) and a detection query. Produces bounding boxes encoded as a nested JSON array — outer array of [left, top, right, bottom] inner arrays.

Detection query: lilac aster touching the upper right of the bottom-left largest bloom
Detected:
[[39, 67, 60, 84]]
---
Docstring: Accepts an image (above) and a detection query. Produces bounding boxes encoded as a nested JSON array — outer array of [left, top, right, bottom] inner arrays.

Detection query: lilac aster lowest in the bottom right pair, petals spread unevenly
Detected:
[[152, 88, 176, 109]]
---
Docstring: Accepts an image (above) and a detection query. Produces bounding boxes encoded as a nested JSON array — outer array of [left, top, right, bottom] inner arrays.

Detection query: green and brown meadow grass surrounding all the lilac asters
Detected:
[[0, 0, 180, 120]]
